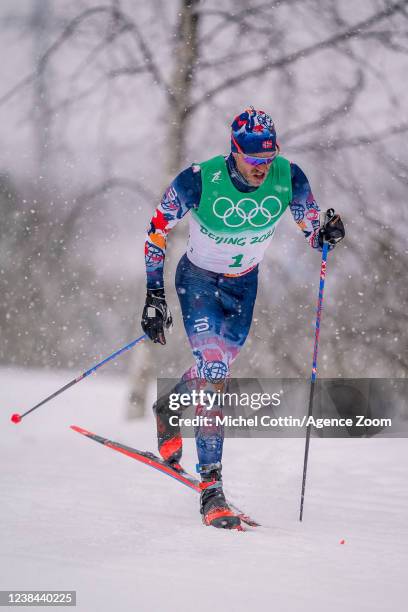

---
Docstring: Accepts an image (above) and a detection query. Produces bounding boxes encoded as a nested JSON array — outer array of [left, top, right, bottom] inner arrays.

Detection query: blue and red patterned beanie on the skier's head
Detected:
[[231, 106, 276, 154]]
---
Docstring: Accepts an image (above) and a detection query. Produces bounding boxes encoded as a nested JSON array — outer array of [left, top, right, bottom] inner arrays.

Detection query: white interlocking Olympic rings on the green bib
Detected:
[[213, 196, 282, 228]]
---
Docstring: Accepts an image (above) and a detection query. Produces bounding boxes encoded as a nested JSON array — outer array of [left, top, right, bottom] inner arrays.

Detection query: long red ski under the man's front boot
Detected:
[[71, 425, 260, 531]]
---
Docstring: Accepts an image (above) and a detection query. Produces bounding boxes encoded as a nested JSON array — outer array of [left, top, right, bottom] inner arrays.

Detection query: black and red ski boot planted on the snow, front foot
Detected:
[[199, 463, 241, 529]]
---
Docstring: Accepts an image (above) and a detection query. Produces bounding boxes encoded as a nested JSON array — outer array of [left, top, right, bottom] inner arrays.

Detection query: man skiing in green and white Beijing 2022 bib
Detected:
[[142, 106, 345, 528]]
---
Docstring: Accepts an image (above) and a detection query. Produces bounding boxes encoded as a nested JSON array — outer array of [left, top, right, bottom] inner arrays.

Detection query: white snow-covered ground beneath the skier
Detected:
[[0, 369, 408, 612]]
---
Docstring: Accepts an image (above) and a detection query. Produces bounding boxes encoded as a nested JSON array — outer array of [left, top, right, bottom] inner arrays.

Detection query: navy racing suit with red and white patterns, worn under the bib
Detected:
[[145, 155, 321, 466]]
